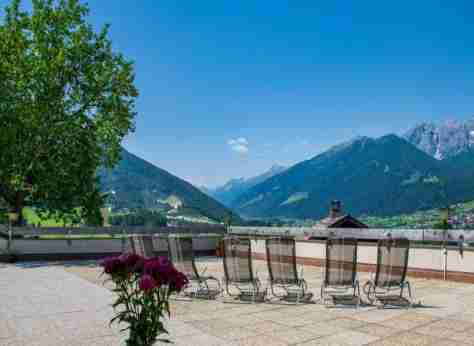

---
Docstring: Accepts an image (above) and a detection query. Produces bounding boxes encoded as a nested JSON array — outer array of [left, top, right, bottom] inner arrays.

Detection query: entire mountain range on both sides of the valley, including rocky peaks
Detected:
[[100, 118, 474, 220]]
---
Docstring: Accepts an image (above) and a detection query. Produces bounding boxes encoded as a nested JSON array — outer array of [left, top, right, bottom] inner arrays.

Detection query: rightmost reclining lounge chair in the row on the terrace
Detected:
[[364, 237, 413, 308]]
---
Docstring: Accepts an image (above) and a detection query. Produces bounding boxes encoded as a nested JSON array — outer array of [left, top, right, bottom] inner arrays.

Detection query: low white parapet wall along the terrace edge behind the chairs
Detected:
[[0, 228, 474, 283]]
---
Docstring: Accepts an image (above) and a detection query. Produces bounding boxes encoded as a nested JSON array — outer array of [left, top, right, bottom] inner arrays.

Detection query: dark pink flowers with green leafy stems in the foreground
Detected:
[[100, 254, 188, 346]]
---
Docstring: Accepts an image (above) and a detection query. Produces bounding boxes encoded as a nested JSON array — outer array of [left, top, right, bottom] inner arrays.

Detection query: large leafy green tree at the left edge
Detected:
[[0, 0, 138, 223]]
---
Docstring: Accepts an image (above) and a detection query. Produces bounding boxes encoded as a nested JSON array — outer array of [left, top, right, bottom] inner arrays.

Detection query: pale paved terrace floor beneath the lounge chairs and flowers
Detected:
[[0, 260, 474, 346]]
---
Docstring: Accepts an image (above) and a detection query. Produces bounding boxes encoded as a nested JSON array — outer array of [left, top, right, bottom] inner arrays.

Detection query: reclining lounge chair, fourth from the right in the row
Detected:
[[223, 236, 266, 302]]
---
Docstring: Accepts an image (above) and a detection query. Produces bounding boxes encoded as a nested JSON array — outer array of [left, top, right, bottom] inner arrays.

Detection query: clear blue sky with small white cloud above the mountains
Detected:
[[0, 0, 474, 186]]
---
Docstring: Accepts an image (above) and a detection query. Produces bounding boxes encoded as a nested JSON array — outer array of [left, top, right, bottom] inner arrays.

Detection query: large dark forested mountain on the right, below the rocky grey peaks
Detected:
[[231, 135, 474, 219]]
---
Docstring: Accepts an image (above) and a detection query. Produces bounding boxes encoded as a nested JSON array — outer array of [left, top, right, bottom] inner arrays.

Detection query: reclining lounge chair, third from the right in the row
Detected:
[[265, 237, 312, 303]]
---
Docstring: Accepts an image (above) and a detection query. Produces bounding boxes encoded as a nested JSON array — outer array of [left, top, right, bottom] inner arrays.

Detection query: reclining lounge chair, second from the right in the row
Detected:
[[321, 238, 360, 308]]
